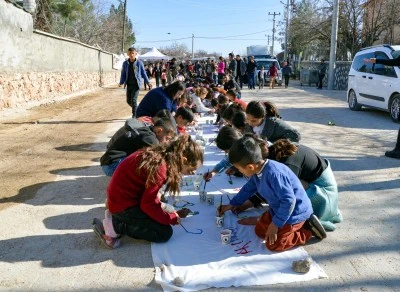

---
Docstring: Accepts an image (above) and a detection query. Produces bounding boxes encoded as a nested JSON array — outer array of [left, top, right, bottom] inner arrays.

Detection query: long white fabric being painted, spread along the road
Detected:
[[151, 117, 327, 291]]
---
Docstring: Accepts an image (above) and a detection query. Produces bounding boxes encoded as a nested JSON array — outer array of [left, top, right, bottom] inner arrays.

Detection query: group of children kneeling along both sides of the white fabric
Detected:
[[93, 78, 342, 251]]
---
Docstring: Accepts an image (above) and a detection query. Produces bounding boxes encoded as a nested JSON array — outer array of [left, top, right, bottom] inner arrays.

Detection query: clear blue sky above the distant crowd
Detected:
[[119, 0, 286, 56]]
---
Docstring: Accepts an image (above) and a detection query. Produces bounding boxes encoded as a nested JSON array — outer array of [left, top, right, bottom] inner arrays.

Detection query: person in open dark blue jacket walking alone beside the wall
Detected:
[[119, 47, 151, 118]]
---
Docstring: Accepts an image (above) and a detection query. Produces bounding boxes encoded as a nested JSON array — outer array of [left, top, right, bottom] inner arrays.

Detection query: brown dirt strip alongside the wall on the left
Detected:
[[0, 86, 134, 210]]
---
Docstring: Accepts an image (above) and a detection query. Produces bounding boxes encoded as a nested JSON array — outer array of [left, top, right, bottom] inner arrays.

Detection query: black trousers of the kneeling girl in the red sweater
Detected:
[[112, 206, 173, 242]]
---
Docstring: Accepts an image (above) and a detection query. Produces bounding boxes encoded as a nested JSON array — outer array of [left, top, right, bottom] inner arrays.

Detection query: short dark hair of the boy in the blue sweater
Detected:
[[228, 135, 263, 167]]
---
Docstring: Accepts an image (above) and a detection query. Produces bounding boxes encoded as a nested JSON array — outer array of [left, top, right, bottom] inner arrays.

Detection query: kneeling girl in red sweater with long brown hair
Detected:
[[93, 135, 203, 249]]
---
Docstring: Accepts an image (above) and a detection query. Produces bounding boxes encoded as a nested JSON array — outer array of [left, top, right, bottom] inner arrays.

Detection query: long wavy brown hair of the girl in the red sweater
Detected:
[[136, 135, 203, 194]]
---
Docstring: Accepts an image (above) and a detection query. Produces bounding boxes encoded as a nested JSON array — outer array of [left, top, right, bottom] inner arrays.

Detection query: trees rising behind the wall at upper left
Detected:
[[35, 0, 135, 53]]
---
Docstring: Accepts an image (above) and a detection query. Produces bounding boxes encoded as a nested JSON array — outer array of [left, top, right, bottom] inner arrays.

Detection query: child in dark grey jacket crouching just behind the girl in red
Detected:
[[100, 118, 176, 176]]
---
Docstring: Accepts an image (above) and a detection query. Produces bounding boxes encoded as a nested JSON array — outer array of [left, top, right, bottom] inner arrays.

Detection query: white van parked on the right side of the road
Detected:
[[347, 45, 400, 122]]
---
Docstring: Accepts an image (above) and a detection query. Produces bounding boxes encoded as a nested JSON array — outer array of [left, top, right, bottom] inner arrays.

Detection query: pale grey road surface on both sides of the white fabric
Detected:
[[0, 82, 400, 291]]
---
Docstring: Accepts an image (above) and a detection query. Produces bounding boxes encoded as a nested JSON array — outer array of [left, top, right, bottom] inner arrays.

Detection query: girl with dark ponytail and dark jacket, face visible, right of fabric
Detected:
[[246, 101, 300, 142]]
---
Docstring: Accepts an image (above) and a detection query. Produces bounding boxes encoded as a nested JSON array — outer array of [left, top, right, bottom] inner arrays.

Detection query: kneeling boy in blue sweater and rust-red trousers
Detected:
[[220, 136, 326, 251]]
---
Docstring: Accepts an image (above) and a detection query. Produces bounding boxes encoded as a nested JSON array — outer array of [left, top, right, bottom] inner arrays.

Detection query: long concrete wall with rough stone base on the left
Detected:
[[0, 0, 119, 110]]
